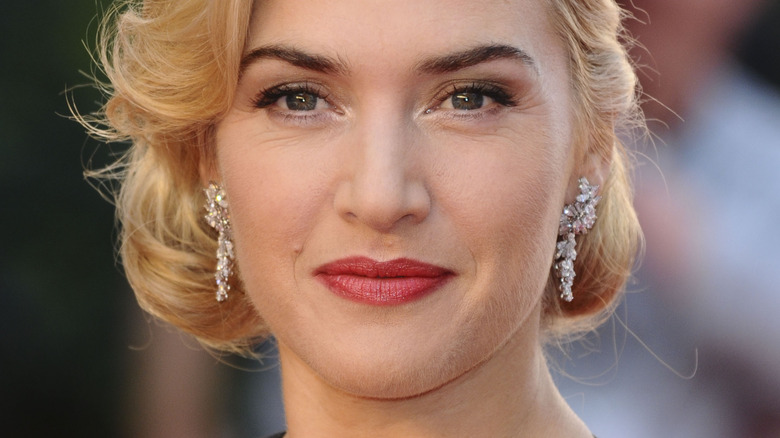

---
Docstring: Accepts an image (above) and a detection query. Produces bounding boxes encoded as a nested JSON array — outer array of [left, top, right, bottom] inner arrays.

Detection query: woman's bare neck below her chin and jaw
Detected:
[[279, 320, 591, 438]]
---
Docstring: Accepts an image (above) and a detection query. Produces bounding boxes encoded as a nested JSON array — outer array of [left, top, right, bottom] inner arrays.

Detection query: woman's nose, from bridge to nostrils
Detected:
[[334, 114, 431, 232]]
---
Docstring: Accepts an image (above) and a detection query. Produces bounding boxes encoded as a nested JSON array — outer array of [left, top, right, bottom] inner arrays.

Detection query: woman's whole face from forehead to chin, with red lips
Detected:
[[214, 0, 576, 398]]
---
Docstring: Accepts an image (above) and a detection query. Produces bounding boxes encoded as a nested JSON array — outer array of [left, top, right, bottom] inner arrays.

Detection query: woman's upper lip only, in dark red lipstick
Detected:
[[314, 256, 453, 278]]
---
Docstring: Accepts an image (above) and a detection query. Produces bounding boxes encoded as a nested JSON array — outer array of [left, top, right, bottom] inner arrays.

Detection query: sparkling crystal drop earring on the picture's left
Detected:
[[204, 182, 235, 303]]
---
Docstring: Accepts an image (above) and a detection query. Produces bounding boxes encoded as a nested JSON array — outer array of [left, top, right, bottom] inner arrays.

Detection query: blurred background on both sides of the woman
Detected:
[[0, 0, 780, 438]]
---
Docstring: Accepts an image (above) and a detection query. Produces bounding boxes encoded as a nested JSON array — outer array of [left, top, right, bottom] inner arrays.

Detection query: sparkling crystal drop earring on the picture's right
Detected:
[[553, 177, 601, 302]]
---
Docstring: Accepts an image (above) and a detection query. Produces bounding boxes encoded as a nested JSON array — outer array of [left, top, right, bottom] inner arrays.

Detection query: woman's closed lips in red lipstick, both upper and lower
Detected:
[[314, 257, 454, 305]]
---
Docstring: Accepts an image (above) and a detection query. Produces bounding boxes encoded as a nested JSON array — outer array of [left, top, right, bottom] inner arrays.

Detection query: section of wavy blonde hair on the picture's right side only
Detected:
[[545, 0, 646, 340]]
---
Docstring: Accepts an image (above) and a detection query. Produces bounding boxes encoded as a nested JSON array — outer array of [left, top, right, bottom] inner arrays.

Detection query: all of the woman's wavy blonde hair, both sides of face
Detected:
[[77, 0, 639, 353]]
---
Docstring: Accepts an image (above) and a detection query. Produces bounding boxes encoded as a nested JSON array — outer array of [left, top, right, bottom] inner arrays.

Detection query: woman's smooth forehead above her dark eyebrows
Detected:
[[247, 0, 562, 71]]
